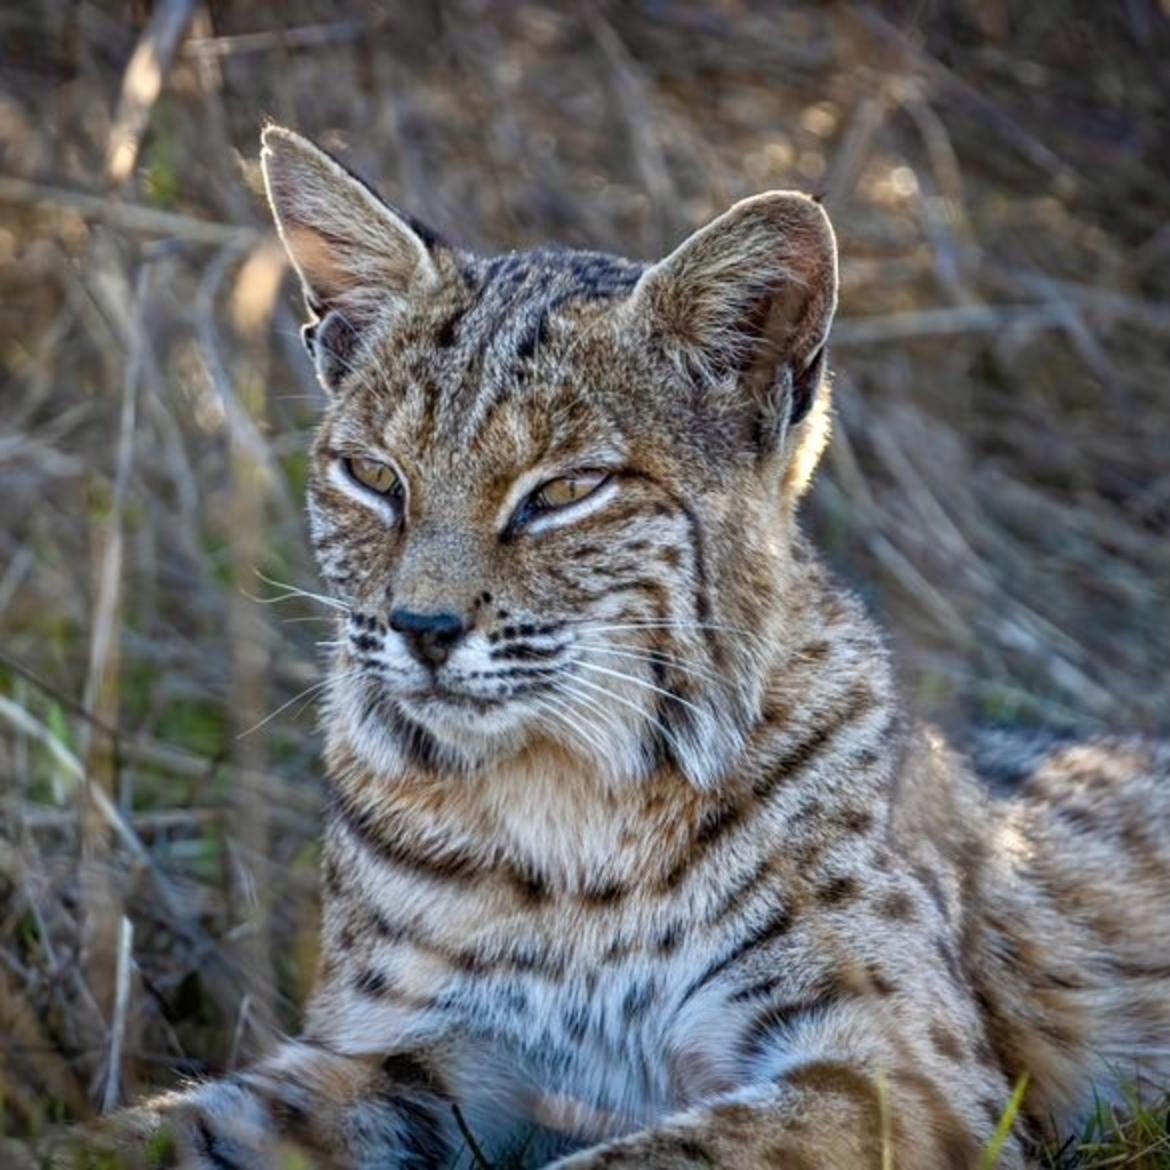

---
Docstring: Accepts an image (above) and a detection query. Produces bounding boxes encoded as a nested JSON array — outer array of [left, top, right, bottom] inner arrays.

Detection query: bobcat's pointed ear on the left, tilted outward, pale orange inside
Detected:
[[260, 126, 441, 390]]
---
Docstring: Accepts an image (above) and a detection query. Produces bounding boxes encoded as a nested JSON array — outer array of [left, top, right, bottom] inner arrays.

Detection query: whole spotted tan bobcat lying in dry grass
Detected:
[[102, 126, 1170, 1170]]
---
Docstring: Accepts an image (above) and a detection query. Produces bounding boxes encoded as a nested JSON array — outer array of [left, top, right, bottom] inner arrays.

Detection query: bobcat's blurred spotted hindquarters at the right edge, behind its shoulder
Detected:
[[968, 736, 1170, 1126]]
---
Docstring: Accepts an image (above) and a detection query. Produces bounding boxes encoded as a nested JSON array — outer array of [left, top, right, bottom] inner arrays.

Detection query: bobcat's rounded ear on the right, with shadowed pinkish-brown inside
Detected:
[[632, 191, 837, 442]]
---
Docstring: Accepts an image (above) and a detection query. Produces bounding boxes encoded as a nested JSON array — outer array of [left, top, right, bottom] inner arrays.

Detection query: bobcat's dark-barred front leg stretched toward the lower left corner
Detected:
[[115, 1041, 457, 1170]]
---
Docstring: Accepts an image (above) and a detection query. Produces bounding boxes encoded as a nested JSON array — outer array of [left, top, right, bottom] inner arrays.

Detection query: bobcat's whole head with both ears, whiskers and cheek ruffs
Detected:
[[262, 126, 837, 785]]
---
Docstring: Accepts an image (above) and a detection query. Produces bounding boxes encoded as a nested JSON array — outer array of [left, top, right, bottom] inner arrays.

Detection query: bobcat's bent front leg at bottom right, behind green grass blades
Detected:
[[552, 1059, 1025, 1170]]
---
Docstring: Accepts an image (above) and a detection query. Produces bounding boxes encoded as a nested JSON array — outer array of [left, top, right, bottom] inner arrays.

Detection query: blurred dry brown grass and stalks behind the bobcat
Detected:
[[0, 0, 1170, 1165]]
